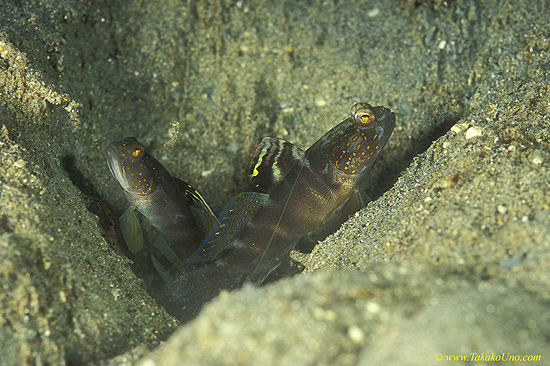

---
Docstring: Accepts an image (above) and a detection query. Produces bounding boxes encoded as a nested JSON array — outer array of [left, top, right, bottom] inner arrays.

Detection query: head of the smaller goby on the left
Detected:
[[106, 137, 168, 197]]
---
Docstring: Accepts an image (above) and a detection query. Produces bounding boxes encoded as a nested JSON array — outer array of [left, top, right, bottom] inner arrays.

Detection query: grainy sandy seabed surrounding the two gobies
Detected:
[[0, 0, 550, 366]]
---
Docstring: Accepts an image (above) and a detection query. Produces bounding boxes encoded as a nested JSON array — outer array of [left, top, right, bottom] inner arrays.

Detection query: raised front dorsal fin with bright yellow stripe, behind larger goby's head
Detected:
[[248, 137, 304, 193]]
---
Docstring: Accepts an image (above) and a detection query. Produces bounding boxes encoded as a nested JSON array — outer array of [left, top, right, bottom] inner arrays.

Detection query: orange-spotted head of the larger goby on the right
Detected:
[[306, 103, 395, 181]]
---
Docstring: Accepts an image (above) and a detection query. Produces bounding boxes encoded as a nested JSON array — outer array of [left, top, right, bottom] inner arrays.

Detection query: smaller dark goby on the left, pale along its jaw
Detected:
[[106, 137, 217, 259]]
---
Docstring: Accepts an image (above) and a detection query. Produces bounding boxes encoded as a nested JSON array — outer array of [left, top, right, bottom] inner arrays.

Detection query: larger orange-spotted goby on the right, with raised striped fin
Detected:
[[170, 103, 395, 318]]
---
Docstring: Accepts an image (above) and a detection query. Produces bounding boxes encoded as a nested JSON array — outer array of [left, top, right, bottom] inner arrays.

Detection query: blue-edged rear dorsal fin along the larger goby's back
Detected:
[[189, 192, 269, 262]]
